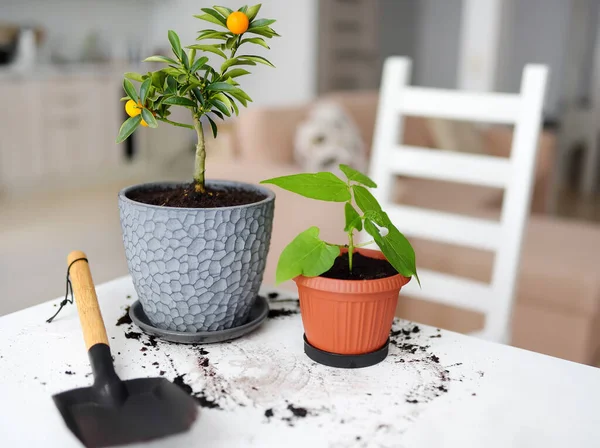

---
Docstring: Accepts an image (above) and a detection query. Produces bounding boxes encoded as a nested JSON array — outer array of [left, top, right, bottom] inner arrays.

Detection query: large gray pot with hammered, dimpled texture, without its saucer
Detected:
[[119, 181, 275, 332]]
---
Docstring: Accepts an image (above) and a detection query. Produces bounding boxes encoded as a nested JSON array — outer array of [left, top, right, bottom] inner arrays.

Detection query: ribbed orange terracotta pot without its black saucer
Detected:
[[294, 249, 410, 355]]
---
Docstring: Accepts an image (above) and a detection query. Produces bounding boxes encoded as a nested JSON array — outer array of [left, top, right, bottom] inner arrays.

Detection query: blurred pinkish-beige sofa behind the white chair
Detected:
[[208, 92, 600, 364]]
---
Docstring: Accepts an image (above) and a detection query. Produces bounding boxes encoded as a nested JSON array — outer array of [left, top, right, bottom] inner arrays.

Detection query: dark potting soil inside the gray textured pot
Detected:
[[127, 184, 266, 208]]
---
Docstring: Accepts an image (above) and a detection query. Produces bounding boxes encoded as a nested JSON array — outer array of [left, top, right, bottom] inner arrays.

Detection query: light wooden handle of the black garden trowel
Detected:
[[67, 250, 108, 350]]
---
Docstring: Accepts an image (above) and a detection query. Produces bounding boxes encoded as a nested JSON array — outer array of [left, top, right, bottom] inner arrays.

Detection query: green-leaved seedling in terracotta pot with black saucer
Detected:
[[262, 165, 418, 367]]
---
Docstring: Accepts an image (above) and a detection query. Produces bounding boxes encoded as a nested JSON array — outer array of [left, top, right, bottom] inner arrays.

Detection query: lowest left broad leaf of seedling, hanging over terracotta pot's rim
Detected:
[[275, 227, 340, 283]]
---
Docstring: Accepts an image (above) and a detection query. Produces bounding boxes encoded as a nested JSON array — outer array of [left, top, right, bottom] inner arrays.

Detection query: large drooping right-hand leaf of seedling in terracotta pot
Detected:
[[365, 211, 421, 286]]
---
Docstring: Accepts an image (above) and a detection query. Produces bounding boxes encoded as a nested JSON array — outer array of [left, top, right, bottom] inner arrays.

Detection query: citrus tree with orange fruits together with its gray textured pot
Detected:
[[117, 5, 278, 332]]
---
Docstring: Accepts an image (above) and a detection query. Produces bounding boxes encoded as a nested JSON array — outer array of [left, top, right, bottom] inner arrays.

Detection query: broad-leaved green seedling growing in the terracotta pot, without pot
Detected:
[[261, 165, 420, 284]]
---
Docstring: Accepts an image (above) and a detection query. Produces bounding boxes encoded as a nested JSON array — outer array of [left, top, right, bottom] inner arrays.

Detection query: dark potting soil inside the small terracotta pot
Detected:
[[321, 252, 398, 280]]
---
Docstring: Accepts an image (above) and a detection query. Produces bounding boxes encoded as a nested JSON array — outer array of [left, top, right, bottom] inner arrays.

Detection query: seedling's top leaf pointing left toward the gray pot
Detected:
[[261, 172, 351, 202]]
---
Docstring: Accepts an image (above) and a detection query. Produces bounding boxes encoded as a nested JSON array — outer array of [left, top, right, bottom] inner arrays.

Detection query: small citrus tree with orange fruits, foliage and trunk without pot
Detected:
[[117, 4, 279, 193]]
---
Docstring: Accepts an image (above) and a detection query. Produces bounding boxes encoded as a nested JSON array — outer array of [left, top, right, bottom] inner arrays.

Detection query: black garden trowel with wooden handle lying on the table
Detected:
[[53, 251, 198, 447]]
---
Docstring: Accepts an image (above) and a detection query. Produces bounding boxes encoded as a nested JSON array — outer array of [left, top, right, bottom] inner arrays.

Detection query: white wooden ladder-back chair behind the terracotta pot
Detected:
[[370, 57, 548, 342]]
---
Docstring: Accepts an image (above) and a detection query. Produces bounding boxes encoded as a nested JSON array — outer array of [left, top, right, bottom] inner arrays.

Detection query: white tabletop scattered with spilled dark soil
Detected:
[[0, 277, 600, 448]]
